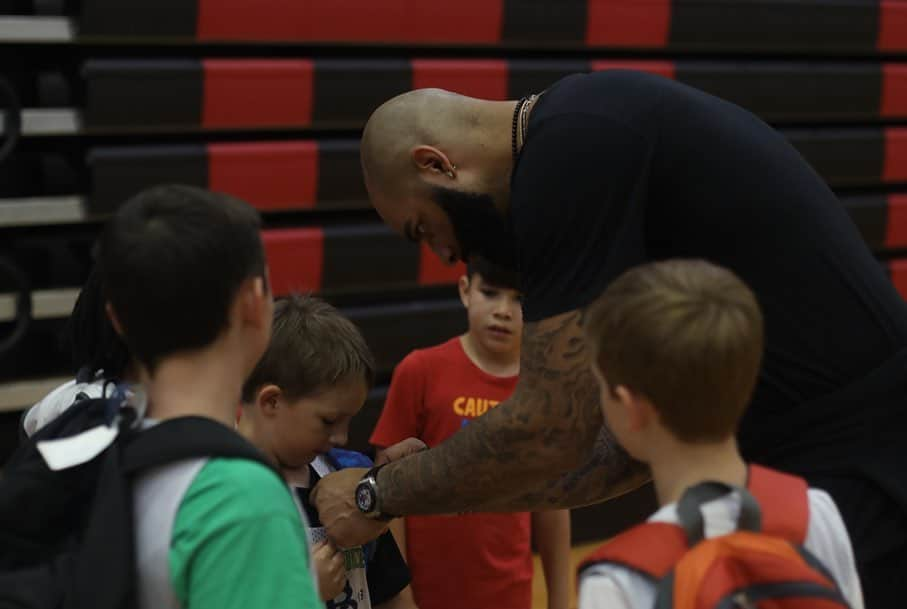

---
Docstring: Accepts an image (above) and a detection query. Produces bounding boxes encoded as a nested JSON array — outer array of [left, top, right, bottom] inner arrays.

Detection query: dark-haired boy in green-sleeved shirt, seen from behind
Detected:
[[99, 186, 318, 609]]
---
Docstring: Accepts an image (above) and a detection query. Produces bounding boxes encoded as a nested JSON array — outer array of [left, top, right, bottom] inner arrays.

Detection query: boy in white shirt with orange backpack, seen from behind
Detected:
[[579, 260, 863, 609]]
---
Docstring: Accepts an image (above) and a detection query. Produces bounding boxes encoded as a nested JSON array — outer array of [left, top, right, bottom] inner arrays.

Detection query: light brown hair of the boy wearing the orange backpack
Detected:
[[586, 260, 763, 442]]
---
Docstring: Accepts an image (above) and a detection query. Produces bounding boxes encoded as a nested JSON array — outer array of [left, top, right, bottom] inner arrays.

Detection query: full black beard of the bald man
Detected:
[[432, 186, 518, 271]]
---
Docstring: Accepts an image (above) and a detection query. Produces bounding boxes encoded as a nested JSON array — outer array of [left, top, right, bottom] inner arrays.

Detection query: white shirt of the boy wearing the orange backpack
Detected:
[[579, 489, 863, 609]]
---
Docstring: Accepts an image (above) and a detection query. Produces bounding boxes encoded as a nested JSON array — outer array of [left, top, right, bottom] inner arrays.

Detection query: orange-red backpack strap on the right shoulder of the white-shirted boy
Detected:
[[746, 465, 809, 546]]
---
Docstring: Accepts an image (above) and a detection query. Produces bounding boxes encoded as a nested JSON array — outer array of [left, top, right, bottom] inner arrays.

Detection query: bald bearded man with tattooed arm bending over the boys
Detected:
[[315, 71, 907, 608]]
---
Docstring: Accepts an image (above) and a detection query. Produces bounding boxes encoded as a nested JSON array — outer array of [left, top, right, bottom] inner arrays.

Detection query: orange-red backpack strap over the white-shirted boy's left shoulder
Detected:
[[577, 522, 687, 580]]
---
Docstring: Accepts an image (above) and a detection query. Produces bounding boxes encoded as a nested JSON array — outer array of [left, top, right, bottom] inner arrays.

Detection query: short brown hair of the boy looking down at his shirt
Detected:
[[242, 294, 375, 403]]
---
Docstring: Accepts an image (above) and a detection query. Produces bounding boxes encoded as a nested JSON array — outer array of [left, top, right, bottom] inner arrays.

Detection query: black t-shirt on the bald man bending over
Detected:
[[511, 70, 907, 466]]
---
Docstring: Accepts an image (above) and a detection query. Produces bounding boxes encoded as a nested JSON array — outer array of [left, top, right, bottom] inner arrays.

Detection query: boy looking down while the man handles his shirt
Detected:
[[238, 295, 415, 609]]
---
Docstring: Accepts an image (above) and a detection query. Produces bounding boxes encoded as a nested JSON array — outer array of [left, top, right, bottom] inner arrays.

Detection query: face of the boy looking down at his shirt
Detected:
[[269, 377, 367, 471]]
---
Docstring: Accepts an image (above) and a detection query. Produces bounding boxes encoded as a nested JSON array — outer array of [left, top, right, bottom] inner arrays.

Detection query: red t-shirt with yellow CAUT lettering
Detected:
[[371, 338, 532, 609]]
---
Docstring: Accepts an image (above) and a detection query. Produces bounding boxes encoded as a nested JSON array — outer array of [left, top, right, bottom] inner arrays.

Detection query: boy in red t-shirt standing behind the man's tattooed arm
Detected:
[[371, 261, 571, 609]]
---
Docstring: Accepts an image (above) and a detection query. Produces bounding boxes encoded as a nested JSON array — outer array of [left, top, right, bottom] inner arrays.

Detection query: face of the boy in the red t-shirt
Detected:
[[460, 274, 523, 353]]
